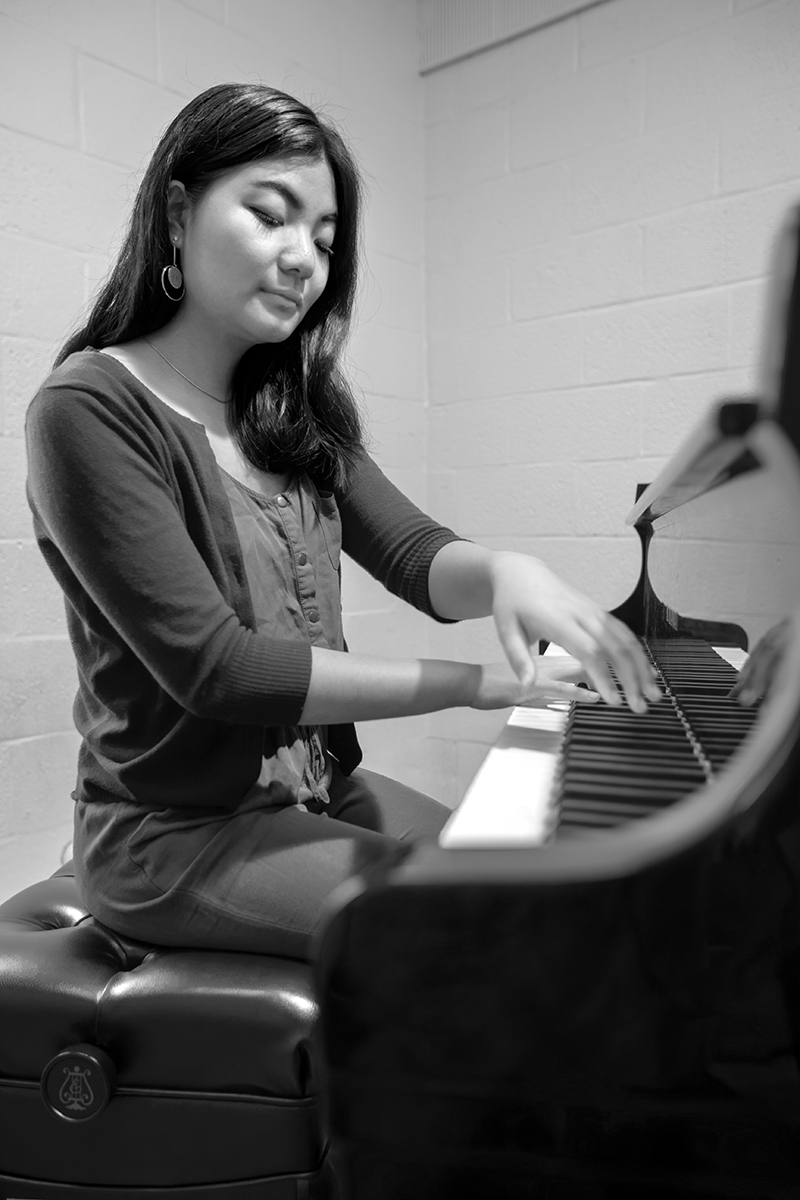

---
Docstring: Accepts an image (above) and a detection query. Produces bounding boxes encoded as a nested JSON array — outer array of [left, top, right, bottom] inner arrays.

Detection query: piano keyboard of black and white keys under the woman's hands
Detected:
[[439, 638, 757, 847]]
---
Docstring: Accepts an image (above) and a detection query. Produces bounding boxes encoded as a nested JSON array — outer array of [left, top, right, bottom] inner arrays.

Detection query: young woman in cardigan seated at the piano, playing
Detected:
[[26, 84, 657, 958]]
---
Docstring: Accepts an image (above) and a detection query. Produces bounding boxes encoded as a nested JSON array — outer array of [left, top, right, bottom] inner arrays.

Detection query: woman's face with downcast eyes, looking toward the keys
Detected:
[[172, 156, 336, 352]]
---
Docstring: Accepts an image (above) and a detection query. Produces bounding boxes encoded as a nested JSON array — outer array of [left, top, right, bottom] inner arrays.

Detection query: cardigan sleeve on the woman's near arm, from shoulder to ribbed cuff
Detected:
[[26, 384, 311, 725]]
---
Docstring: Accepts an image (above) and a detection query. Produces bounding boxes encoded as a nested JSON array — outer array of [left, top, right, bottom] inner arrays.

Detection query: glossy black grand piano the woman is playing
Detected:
[[317, 214, 800, 1200]]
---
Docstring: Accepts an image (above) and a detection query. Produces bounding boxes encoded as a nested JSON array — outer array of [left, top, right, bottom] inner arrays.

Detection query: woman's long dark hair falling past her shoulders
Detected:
[[56, 83, 362, 487]]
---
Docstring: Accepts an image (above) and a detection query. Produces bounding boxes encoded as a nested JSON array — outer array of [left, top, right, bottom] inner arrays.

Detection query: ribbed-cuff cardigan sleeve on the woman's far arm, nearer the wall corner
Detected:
[[337, 452, 464, 624]]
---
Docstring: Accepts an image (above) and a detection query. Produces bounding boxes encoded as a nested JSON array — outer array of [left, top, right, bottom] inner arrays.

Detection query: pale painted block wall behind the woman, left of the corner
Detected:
[[0, 0, 425, 899]]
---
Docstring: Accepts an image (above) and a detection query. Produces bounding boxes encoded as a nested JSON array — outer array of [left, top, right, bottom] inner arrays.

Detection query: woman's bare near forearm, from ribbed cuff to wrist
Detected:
[[300, 646, 481, 725]]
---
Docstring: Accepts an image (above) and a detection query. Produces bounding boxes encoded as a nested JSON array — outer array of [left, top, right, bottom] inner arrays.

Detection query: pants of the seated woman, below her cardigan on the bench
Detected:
[[74, 769, 450, 959]]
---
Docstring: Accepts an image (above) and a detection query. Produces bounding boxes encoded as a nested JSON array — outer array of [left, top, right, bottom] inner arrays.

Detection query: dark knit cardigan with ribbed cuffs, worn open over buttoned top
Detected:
[[25, 350, 456, 809]]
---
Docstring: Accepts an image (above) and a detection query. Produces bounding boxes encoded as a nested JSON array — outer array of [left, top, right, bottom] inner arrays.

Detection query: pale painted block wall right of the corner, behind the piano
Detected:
[[425, 0, 800, 803]]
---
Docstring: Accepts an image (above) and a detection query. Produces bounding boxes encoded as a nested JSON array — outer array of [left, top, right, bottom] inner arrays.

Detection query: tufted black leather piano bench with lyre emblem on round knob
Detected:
[[0, 864, 325, 1200]]
